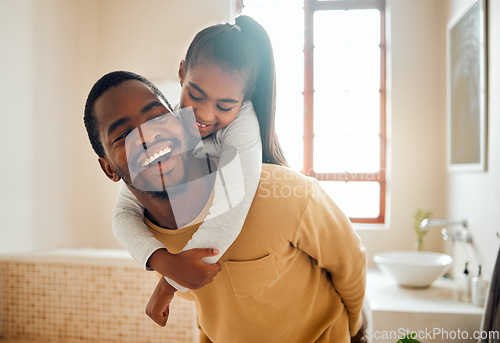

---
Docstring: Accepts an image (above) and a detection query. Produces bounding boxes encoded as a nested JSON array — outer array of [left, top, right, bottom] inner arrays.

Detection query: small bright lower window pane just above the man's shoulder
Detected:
[[319, 181, 380, 218]]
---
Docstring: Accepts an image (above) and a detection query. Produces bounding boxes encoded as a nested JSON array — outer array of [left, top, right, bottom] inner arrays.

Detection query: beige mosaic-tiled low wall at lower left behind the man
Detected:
[[0, 251, 197, 343]]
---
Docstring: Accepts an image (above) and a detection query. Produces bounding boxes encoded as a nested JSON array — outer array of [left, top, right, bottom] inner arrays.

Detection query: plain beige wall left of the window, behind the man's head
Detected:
[[0, 0, 234, 253]]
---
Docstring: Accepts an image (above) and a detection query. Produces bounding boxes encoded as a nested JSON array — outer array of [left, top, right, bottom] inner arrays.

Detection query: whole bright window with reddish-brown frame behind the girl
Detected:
[[243, 0, 386, 223]]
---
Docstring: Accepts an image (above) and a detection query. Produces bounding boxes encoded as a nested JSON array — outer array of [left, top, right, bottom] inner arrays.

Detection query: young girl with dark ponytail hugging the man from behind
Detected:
[[113, 16, 286, 292]]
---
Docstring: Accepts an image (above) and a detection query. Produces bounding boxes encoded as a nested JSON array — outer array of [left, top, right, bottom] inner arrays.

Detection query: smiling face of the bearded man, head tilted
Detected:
[[94, 80, 193, 191]]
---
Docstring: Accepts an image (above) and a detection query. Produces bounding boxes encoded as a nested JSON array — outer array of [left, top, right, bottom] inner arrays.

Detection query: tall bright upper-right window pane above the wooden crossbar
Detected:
[[313, 10, 380, 172]]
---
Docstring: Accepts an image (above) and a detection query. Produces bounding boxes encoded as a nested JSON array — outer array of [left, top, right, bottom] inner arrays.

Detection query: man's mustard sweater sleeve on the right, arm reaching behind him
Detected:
[[292, 180, 366, 336]]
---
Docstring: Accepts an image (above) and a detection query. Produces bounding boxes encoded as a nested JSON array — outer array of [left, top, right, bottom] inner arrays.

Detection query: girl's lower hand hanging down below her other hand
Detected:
[[146, 278, 175, 326]]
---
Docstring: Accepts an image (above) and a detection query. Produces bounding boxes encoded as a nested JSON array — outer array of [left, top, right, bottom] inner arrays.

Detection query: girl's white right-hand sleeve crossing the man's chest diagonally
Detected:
[[167, 102, 262, 291]]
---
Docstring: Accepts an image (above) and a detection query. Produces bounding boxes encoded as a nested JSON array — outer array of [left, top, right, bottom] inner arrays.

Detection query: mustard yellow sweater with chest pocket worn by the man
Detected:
[[147, 164, 366, 343]]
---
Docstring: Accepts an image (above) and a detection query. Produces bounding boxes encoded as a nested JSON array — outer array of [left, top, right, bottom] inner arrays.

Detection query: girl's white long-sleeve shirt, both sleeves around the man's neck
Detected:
[[113, 101, 262, 292]]
